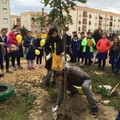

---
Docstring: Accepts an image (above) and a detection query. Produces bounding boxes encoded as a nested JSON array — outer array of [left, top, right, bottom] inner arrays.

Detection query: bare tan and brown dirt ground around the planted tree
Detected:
[[0, 60, 117, 120]]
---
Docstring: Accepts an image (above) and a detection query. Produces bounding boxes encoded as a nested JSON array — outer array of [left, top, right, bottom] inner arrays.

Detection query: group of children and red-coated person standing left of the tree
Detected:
[[0, 25, 43, 77]]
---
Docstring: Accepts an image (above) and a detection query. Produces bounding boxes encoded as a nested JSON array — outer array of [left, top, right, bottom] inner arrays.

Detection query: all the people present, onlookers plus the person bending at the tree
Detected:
[[0, 25, 120, 114]]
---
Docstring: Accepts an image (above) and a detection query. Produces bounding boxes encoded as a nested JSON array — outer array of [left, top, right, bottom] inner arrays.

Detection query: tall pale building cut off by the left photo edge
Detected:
[[0, 0, 11, 31]]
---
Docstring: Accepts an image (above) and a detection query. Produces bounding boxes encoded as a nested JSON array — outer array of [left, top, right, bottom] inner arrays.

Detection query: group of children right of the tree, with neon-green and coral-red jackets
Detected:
[[67, 29, 120, 75]]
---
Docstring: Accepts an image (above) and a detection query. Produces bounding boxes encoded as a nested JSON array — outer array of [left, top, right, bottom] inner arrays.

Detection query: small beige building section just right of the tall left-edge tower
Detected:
[[11, 15, 21, 28]]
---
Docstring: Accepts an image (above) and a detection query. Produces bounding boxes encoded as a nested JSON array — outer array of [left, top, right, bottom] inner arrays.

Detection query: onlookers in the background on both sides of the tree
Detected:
[[0, 25, 120, 77]]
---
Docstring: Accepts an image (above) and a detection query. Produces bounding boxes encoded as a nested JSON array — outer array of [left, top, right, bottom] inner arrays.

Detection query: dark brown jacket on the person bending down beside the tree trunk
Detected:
[[56, 66, 90, 106]]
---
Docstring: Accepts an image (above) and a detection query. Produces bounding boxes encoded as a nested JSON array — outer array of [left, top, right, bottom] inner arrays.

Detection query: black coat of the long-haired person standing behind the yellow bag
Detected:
[[44, 36, 63, 70]]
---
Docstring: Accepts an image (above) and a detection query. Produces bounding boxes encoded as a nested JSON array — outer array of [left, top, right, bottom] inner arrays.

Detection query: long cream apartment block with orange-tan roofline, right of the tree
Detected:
[[66, 6, 120, 33]]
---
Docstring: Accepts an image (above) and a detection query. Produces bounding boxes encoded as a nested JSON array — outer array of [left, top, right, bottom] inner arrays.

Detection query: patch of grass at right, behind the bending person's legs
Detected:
[[83, 65, 120, 110]]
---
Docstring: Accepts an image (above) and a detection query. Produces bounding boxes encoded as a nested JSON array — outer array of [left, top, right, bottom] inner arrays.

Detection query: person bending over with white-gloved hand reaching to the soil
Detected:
[[52, 63, 98, 115]]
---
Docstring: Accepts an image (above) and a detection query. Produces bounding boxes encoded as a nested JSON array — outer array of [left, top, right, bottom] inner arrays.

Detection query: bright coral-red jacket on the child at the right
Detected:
[[96, 38, 111, 53]]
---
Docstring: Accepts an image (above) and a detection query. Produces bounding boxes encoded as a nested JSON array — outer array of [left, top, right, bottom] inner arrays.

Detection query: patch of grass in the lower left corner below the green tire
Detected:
[[0, 93, 35, 120]]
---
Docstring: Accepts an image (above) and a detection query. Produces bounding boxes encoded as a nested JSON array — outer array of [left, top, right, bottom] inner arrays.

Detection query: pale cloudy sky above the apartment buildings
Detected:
[[10, 0, 120, 15]]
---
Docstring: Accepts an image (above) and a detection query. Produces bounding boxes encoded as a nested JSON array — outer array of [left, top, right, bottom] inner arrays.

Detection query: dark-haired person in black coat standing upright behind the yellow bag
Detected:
[[45, 28, 63, 88]]
